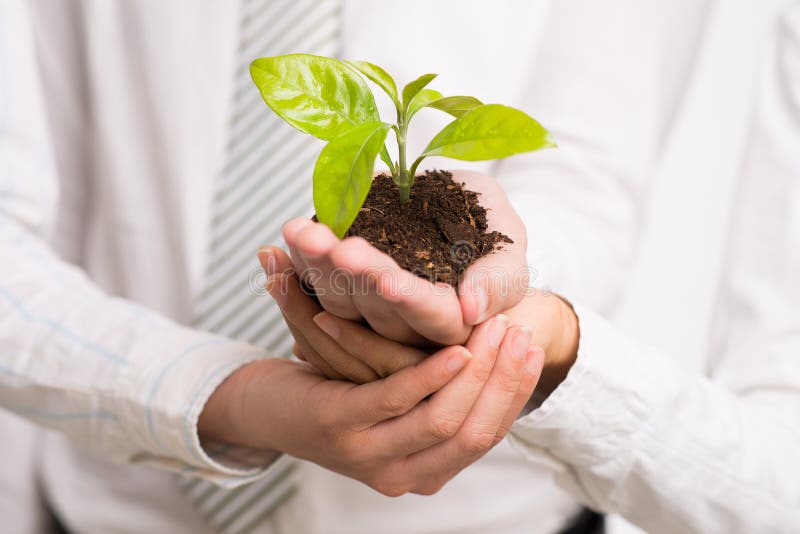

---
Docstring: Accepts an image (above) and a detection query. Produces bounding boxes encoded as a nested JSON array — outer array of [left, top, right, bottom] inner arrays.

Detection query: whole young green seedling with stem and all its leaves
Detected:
[[250, 54, 556, 238]]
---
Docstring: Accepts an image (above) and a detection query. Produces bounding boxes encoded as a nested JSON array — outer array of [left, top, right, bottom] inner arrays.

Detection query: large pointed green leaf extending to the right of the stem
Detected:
[[421, 104, 556, 161]]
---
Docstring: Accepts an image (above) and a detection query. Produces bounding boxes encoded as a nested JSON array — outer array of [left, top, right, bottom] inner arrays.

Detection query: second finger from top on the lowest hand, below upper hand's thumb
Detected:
[[372, 315, 508, 457]]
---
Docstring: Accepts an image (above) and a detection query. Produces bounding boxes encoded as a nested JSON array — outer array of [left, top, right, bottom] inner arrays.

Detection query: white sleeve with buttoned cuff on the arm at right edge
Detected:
[[512, 5, 800, 533]]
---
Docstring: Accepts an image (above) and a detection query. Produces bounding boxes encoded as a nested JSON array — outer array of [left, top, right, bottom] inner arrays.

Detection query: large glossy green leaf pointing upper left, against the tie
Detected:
[[250, 54, 380, 141]]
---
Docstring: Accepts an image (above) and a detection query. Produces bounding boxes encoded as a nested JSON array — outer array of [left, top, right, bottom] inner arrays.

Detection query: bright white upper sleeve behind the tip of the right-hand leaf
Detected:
[[493, 0, 710, 312]]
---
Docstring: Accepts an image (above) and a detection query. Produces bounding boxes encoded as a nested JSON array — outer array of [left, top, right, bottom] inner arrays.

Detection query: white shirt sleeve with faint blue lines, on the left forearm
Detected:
[[0, 218, 276, 482]]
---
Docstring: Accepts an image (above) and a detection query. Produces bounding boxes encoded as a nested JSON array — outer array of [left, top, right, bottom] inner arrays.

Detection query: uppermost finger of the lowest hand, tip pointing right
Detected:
[[342, 346, 472, 432]]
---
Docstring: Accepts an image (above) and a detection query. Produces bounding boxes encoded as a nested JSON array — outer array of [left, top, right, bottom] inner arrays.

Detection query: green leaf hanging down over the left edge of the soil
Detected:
[[314, 121, 391, 238]]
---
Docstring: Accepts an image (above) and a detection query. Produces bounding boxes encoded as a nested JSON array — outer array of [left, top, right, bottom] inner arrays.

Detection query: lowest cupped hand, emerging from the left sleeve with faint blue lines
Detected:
[[199, 310, 544, 495]]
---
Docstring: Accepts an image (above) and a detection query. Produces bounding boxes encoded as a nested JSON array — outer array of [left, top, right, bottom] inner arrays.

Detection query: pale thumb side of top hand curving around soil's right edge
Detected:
[[454, 171, 528, 324]]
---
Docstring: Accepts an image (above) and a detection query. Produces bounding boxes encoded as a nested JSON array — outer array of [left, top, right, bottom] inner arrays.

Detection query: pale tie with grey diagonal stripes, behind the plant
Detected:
[[180, 0, 341, 534]]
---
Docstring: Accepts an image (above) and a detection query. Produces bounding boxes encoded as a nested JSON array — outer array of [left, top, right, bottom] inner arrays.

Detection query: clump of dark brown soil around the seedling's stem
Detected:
[[347, 170, 513, 287]]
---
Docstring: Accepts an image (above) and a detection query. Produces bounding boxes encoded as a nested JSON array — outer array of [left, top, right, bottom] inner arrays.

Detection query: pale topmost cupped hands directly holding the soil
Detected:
[[276, 171, 527, 346]]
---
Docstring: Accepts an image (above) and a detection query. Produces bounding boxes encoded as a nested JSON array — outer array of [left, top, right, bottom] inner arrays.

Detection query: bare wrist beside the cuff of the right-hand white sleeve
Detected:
[[507, 291, 580, 396]]
